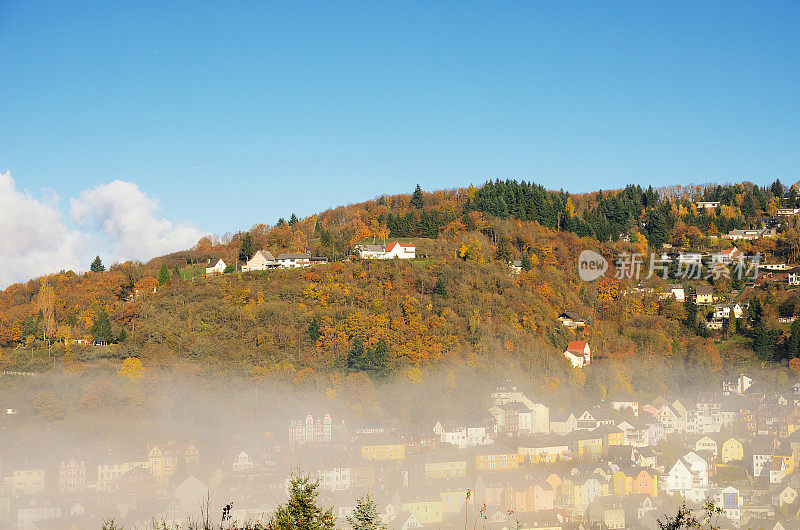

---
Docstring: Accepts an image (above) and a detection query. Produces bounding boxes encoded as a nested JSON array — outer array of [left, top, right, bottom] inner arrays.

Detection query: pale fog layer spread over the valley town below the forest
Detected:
[[0, 370, 800, 530]]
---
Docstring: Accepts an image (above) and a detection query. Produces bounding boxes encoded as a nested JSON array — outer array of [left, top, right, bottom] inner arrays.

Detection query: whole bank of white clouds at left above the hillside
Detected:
[[0, 172, 205, 288]]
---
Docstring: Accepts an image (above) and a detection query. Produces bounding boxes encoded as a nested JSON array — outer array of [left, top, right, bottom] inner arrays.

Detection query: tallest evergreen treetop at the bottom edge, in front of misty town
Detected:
[[267, 474, 336, 530]]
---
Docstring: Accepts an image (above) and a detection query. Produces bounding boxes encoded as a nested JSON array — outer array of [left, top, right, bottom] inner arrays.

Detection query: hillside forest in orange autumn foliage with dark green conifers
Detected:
[[0, 181, 800, 400]]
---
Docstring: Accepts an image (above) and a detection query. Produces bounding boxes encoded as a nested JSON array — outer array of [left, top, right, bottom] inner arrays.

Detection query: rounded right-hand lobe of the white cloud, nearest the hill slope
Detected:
[[70, 180, 205, 260]]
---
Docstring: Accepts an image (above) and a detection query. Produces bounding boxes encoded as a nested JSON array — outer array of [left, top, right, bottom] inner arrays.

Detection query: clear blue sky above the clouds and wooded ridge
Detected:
[[0, 0, 800, 282]]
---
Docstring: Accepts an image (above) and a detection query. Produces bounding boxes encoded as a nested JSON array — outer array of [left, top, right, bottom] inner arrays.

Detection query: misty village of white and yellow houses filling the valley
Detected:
[[7, 374, 800, 530]]
